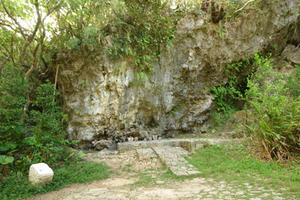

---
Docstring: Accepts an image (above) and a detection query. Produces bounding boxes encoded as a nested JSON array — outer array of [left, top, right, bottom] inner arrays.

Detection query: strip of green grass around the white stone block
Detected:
[[0, 161, 110, 200]]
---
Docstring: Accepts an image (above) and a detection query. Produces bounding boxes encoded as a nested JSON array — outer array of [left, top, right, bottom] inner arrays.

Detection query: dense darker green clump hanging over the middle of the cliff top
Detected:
[[108, 0, 175, 79]]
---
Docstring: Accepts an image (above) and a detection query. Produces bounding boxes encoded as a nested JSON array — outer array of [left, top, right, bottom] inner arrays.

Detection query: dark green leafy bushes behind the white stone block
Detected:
[[0, 65, 68, 172]]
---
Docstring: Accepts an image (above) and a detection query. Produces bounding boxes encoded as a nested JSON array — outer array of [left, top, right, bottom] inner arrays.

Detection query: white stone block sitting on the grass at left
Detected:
[[29, 163, 54, 185]]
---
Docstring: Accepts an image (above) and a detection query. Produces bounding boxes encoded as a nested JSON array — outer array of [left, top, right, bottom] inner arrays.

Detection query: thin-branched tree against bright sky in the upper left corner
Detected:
[[0, 0, 63, 79]]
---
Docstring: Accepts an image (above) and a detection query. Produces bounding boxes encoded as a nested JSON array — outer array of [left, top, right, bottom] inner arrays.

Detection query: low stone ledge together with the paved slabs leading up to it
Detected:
[[117, 138, 232, 176]]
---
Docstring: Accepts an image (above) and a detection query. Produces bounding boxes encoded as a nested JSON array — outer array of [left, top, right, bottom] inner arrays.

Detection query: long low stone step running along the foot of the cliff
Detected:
[[117, 138, 235, 152]]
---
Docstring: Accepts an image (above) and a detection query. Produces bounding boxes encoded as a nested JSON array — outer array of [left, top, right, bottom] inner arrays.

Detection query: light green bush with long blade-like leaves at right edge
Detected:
[[246, 55, 300, 160]]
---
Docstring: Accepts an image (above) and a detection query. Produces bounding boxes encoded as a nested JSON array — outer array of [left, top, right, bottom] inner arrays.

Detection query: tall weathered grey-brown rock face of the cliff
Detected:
[[58, 0, 300, 142]]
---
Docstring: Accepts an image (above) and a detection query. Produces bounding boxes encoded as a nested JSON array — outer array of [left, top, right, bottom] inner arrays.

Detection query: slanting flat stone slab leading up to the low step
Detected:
[[153, 146, 200, 176]]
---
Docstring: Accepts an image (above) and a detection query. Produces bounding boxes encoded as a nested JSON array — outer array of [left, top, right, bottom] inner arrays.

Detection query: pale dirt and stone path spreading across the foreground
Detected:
[[30, 152, 284, 200]]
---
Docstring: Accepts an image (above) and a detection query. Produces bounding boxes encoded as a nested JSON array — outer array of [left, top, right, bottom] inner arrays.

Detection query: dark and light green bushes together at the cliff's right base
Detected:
[[211, 53, 300, 161]]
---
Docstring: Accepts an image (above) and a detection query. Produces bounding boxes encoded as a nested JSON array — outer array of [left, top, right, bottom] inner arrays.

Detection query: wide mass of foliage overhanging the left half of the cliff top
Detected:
[[48, 0, 176, 81]]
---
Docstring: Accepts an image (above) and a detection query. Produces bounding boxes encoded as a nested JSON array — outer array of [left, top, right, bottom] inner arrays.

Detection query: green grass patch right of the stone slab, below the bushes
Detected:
[[188, 144, 300, 199]]
